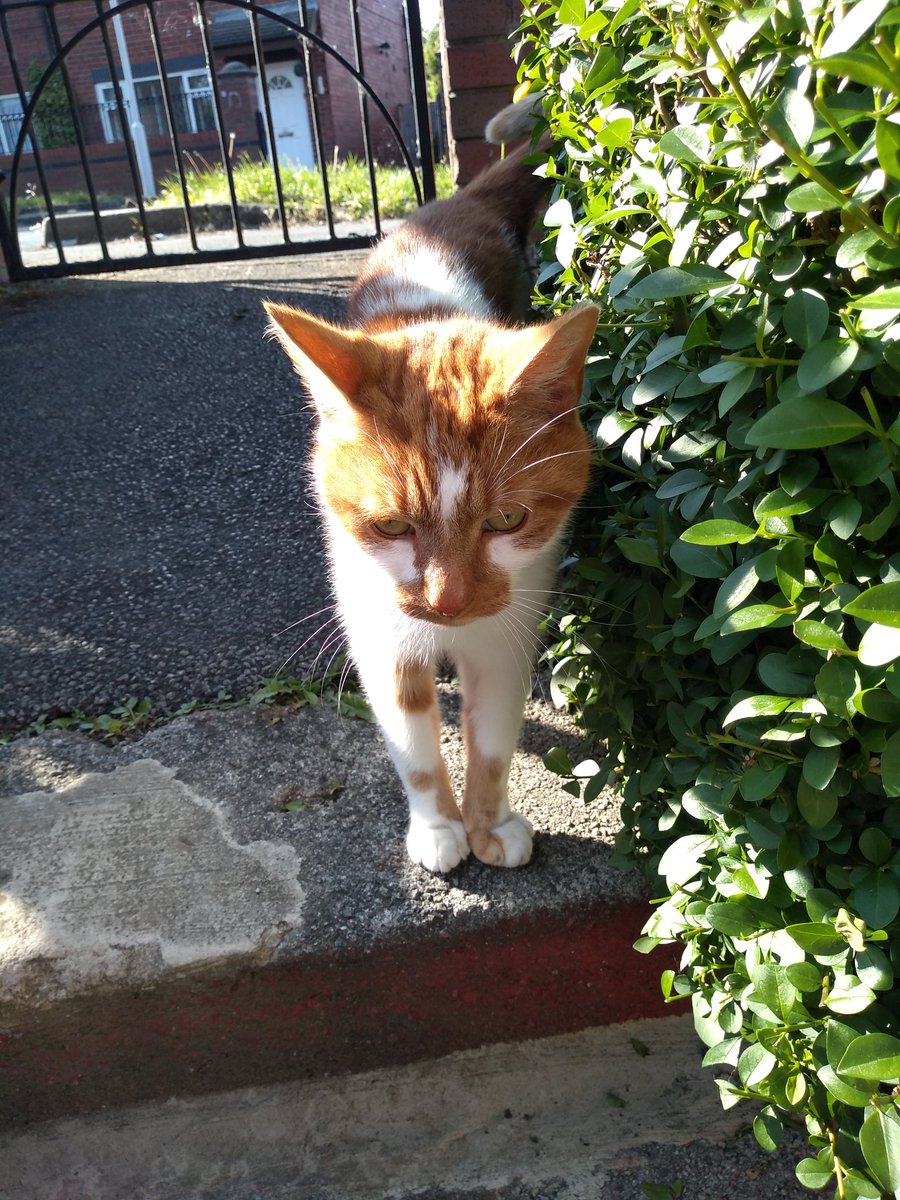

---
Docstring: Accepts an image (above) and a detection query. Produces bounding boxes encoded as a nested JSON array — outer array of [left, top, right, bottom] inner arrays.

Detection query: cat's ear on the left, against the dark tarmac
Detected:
[[263, 301, 379, 412]]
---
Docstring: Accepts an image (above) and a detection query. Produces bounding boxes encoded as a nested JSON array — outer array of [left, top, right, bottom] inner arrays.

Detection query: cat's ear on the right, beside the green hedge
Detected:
[[509, 304, 600, 414]]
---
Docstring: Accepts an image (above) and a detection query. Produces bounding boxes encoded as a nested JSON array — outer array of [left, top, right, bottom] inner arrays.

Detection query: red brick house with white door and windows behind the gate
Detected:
[[0, 0, 410, 196]]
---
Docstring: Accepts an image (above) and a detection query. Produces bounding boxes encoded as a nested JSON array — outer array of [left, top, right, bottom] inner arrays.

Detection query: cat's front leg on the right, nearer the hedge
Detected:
[[457, 632, 533, 866]]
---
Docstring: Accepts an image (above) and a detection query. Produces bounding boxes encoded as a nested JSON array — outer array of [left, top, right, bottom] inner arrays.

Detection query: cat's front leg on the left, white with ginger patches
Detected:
[[361, 660, 469, 874]]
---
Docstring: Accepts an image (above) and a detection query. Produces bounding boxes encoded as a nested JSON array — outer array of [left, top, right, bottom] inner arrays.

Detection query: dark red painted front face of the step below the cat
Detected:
[[0, 905, 673, 1126]]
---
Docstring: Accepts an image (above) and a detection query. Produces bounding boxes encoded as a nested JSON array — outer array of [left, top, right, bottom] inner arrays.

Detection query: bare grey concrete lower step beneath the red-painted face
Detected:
[[0, 1016, 806, 1200]]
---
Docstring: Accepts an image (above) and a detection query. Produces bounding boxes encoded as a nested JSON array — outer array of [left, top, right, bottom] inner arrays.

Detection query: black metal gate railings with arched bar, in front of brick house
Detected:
[[0, 0, 434, 281]]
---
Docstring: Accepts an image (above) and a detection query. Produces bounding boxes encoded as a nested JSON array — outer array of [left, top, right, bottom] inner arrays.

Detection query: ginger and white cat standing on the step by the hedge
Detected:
[[266, 100, 598, 871]]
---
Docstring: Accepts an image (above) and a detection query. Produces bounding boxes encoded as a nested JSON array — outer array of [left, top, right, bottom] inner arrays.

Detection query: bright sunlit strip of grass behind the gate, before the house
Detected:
[[155, 156, 452, 224]]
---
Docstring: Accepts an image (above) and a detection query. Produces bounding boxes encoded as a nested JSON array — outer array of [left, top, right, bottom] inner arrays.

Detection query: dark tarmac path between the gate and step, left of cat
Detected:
[[0, 251, 374, 728]]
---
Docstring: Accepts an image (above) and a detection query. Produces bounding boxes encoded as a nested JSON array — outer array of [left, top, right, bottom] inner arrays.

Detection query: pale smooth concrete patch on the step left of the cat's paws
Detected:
[[0, 758, 304, 1003]]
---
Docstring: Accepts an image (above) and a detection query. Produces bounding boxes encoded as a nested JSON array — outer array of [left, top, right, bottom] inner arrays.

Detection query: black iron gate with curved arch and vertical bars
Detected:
[[0, 0, 434, 281]]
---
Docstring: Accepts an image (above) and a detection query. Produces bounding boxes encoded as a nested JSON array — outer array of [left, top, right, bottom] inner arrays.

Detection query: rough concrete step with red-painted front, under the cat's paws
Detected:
[[0, 694, 667, 1126]]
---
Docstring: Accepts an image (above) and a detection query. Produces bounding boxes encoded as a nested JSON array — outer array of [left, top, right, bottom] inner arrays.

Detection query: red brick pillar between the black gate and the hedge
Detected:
[[440, 0, 522, 187]]
